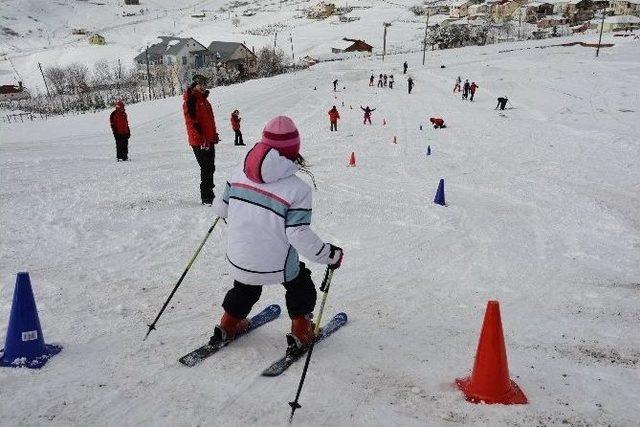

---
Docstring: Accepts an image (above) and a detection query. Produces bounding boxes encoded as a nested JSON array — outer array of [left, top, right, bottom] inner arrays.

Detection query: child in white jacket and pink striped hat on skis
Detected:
[[211, 116, 343, 354]]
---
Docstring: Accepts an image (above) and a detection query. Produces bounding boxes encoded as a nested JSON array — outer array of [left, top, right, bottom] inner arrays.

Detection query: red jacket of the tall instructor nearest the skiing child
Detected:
[[182, 88, 218, 147]]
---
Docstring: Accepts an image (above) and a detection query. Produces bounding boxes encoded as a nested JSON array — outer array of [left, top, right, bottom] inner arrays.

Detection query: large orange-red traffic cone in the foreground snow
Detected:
[[456, 301, 527, 405]]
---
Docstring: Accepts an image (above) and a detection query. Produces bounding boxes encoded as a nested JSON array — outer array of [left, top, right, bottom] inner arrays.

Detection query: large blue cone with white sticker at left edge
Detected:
[[0, 273, 62, 368]]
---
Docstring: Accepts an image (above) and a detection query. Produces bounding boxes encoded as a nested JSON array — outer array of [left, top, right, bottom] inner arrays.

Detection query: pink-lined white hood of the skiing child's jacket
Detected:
[[244, 142, 298, 184]]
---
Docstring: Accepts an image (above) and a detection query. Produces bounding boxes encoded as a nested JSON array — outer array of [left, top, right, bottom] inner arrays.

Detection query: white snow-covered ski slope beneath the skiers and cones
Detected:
[[0, 40, 640, 426]]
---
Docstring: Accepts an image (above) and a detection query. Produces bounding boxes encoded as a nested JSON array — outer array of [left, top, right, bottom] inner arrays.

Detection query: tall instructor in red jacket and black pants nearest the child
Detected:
[[182, 74, 219, 205]]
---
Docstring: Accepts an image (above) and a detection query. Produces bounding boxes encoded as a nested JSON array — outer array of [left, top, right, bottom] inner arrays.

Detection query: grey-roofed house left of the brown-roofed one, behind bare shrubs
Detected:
[[134, 36, 211, 68]]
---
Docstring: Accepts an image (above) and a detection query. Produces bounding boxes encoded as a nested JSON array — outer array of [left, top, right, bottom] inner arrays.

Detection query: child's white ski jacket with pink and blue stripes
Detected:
[[214, 143, 340, 285]]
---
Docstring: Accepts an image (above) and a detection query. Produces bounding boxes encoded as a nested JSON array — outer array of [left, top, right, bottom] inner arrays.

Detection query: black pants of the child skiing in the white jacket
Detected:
[[222, 262, 317, 319]]
